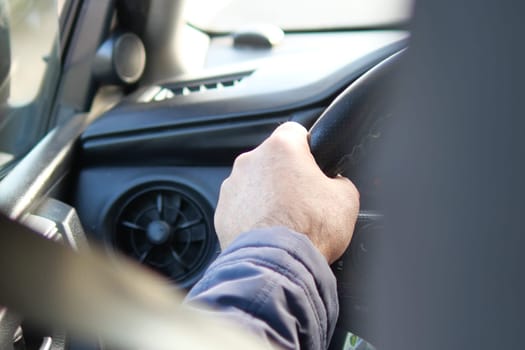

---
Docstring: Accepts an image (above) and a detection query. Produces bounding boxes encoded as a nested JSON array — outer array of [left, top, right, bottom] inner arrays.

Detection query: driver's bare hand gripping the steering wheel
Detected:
[[215, 122, 359, 263]]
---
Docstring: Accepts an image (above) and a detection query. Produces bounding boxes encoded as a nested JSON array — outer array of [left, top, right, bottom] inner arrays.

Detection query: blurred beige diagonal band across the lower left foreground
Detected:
[[0, 215, 268, 349]]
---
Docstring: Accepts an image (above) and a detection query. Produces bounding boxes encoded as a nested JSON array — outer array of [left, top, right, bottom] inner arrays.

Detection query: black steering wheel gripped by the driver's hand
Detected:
[[309, 52, 403, 349]]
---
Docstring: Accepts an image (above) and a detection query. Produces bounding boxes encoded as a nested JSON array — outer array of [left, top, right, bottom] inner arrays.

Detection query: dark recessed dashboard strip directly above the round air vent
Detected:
[[82, 108, 323, 166]]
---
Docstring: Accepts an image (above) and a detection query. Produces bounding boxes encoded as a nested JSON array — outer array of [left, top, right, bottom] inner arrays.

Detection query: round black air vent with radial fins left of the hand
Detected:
[[110, 184, 218, 288]]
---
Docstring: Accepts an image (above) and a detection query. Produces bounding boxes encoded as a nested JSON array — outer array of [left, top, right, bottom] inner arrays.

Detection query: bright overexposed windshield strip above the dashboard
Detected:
[[185, 0, 412, 32]]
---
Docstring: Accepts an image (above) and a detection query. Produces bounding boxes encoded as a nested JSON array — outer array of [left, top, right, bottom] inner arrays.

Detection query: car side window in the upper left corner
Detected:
[[0, 0, 60, 178]]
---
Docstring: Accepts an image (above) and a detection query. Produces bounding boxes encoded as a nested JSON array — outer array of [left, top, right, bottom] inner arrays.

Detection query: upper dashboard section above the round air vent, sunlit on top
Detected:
[[82, 31, 407, 164]]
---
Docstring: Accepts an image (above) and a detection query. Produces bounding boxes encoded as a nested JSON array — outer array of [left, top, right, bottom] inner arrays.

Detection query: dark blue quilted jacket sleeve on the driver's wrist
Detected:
[[187, 227, 339, 350]]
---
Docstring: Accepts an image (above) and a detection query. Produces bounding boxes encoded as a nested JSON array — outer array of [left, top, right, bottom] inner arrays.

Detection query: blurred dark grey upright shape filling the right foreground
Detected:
[[370, 0, 525, 350]]
